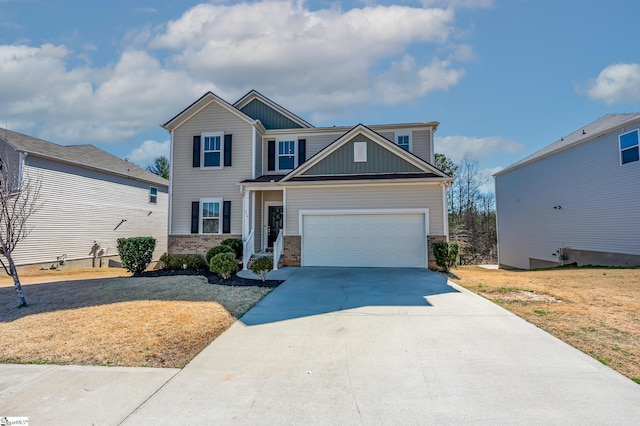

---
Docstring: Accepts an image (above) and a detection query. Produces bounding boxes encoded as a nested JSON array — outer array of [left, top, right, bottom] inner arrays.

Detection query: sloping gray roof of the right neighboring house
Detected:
[[494, 112, 640, 176]]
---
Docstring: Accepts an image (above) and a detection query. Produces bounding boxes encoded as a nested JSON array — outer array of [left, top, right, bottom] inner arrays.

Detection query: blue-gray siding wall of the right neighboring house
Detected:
[[495, 126, 640, 269]]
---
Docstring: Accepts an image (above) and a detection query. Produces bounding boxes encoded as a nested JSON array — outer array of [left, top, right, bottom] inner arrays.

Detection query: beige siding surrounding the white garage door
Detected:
[[285, 184, 444, 235]]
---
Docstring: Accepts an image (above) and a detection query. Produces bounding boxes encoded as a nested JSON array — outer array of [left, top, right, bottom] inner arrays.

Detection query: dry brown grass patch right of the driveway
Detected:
[[450, 266, 640, 383]]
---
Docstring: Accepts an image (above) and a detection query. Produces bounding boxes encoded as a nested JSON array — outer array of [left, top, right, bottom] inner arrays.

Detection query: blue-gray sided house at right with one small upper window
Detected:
[[494, 113, 640, 269]]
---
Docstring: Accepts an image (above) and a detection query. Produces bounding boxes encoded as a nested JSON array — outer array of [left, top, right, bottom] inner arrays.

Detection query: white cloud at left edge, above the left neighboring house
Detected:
[[0, 44, 209, 143]]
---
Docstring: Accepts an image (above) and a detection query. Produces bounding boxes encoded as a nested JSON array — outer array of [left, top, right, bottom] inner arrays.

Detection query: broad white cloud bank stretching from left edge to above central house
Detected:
[[0, 0, 480, 143]]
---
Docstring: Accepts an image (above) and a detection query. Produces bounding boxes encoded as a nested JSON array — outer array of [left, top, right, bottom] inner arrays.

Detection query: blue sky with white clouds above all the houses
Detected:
[[0, 0, 640, 190]]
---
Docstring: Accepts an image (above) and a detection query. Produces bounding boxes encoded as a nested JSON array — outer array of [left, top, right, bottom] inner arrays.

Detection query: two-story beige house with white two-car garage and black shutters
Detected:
[[163, 91, 452, 268]]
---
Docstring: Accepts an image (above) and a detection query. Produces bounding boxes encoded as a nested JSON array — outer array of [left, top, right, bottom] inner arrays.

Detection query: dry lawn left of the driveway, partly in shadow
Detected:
[[0, 268, 271, 367]]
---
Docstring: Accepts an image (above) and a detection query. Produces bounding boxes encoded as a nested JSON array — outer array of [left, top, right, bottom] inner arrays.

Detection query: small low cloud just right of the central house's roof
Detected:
[[434, 136, 525, 163]]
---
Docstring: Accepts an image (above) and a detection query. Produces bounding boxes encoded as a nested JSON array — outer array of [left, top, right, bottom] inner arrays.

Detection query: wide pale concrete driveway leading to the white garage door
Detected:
[[121, 268, 640, 425]]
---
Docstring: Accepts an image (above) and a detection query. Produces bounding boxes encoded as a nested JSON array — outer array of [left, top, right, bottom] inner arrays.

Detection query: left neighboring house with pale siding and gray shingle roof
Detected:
[[0, 129, 169, 267]]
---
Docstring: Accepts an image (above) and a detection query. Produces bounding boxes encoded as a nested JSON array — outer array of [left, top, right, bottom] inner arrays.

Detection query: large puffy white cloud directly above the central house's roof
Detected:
[[149, 1, 468, 114]]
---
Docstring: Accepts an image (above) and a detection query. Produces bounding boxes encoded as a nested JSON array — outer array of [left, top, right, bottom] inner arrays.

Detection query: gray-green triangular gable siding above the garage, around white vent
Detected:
[[300, 133, 424, 176]]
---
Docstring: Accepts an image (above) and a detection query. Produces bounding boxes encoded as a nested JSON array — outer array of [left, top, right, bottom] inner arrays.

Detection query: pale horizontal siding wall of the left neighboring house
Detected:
[[14, 156, 168, 265]]
